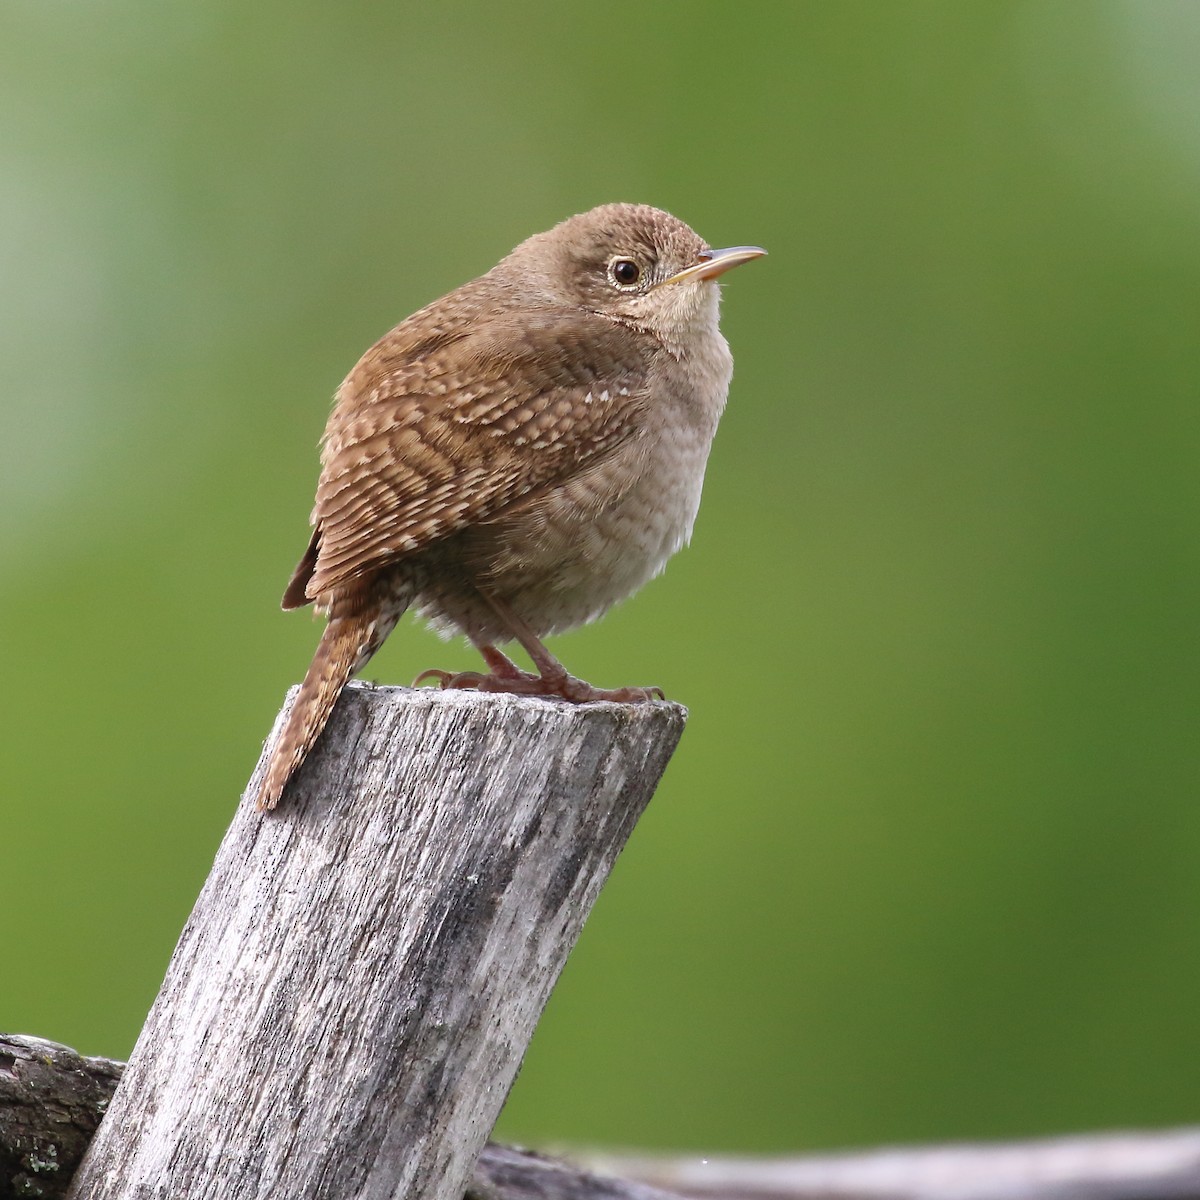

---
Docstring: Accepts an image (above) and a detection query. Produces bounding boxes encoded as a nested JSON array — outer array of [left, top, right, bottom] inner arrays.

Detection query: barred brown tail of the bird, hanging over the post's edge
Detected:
[[256, 607, 403, 811]]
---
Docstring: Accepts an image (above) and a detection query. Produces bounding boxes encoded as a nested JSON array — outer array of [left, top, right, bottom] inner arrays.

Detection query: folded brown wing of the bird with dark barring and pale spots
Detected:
[[300, 311, 648, 602]]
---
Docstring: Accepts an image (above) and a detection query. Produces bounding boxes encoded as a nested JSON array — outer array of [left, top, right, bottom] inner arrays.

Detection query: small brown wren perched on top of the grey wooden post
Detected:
[[258, 204, 764, 809]]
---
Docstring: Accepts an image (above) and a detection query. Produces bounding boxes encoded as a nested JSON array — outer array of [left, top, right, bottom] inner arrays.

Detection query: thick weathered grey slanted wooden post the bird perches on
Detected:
[[63, 684, 685, 1200]]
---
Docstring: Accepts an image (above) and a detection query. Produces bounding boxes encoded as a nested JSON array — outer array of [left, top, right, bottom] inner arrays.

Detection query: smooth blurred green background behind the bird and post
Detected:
[[0, 0, 1200, 1152]]
